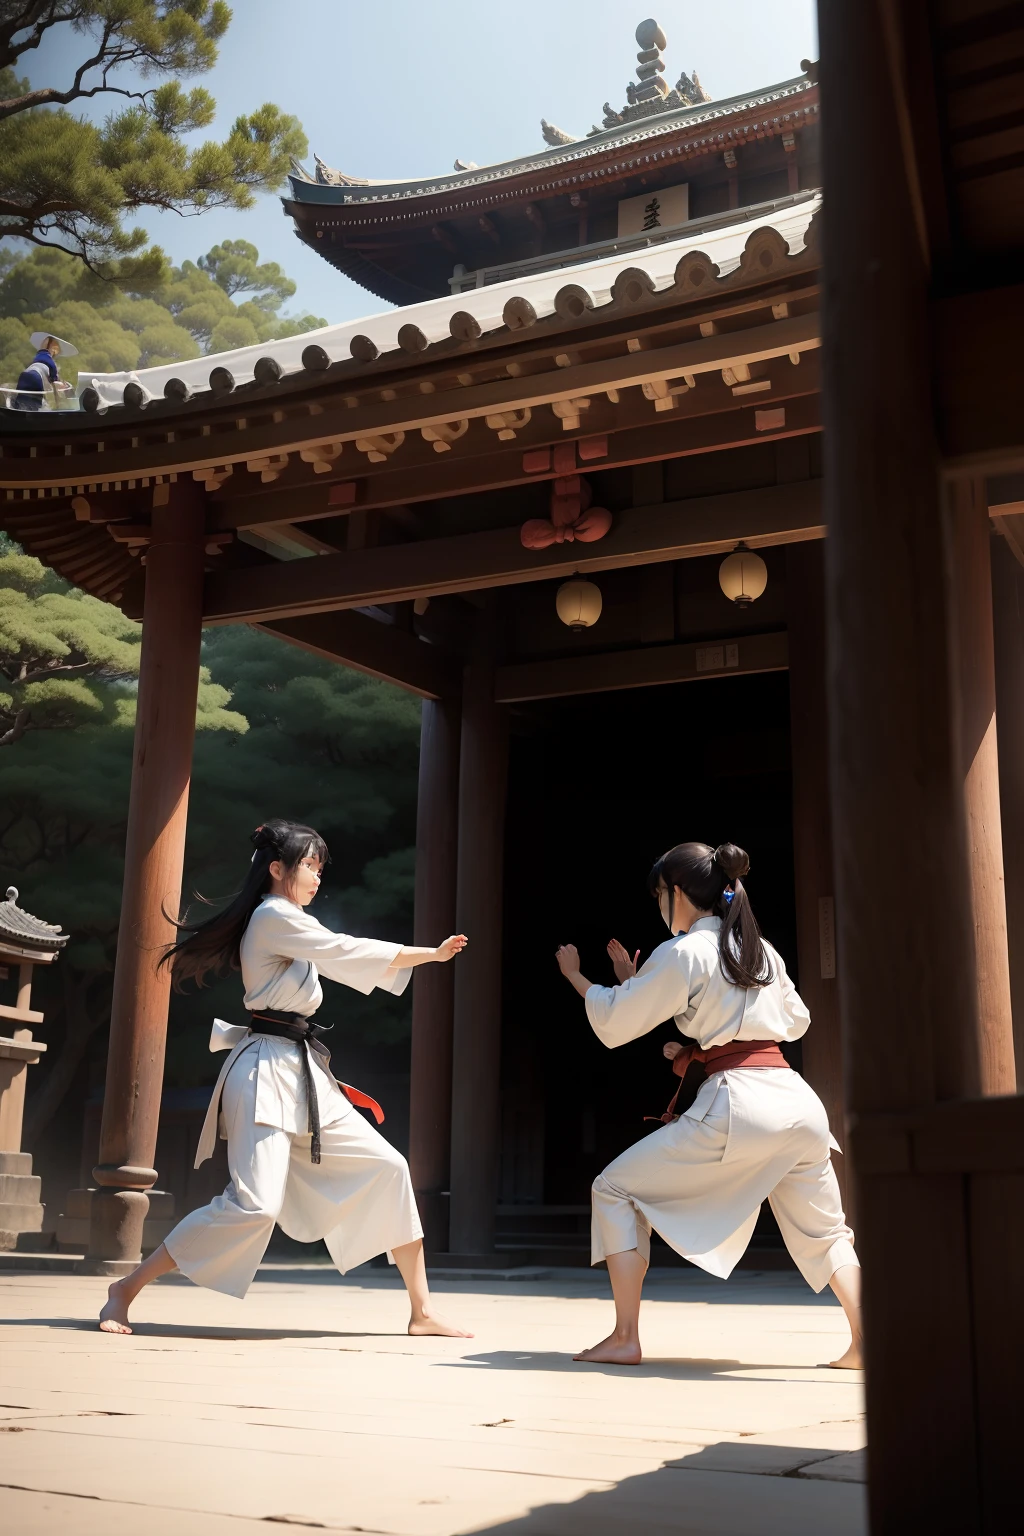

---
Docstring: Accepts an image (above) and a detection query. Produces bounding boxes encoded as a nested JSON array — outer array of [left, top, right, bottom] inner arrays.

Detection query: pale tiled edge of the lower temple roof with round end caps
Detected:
[[80, 192, 821, 410]]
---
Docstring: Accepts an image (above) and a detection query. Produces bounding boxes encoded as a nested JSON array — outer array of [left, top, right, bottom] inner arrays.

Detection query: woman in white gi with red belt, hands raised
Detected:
[[557, 843, 861, 1369]]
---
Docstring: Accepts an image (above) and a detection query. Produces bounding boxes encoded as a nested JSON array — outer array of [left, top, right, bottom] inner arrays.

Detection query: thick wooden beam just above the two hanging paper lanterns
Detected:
[[204, 481, 824, 624]]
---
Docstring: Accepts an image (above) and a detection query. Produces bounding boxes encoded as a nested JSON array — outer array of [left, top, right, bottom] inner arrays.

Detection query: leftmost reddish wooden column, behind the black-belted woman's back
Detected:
[[89, 481, 204, 1273]]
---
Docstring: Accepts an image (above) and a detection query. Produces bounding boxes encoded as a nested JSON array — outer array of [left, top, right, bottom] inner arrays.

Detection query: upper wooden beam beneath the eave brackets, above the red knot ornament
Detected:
[[209, 390, 821, 531]]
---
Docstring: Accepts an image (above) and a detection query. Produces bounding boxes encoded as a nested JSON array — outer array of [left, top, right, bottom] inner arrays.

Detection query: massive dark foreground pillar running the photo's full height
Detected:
[[818, 0, 982, 1536]]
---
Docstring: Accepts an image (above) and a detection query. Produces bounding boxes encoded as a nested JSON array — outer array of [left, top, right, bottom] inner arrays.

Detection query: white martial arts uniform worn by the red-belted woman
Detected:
[[586, 917, 857, 1290]]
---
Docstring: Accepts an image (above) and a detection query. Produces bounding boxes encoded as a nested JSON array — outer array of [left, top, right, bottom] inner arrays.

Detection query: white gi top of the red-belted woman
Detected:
[[586, 917, 811, 1048]]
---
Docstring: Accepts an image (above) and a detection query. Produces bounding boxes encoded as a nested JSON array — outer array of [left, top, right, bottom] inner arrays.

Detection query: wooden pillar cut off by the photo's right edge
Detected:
[[992, 538, 1024, 1091]]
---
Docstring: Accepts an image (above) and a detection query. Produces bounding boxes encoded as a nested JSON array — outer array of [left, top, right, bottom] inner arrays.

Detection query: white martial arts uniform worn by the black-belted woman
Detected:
[[166, 895, 424, 1296]]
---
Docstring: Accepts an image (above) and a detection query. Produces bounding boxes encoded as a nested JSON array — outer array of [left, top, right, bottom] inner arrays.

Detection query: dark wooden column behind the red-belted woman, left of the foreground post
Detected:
[[786, 542, 852, 1217]]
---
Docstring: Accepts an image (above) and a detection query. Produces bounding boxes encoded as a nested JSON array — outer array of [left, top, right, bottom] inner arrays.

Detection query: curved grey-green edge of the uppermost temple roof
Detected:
[[290, 72, 815, 206]]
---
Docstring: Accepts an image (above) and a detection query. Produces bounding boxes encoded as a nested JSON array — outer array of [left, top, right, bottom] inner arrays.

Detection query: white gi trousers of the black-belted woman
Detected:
[[164, 1048, 424, 1296]]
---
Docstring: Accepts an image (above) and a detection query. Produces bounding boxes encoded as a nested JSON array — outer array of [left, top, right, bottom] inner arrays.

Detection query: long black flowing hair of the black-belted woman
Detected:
[[160, 817, 330, 991]]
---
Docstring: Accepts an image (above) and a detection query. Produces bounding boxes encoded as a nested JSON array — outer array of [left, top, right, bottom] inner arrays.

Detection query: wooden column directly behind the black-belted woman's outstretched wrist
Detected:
[[408, 699, 464, 1252]]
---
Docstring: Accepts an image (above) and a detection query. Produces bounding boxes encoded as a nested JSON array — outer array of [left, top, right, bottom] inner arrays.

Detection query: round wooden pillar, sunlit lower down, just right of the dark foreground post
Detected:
[[949, 479, 1024, 1094]]
